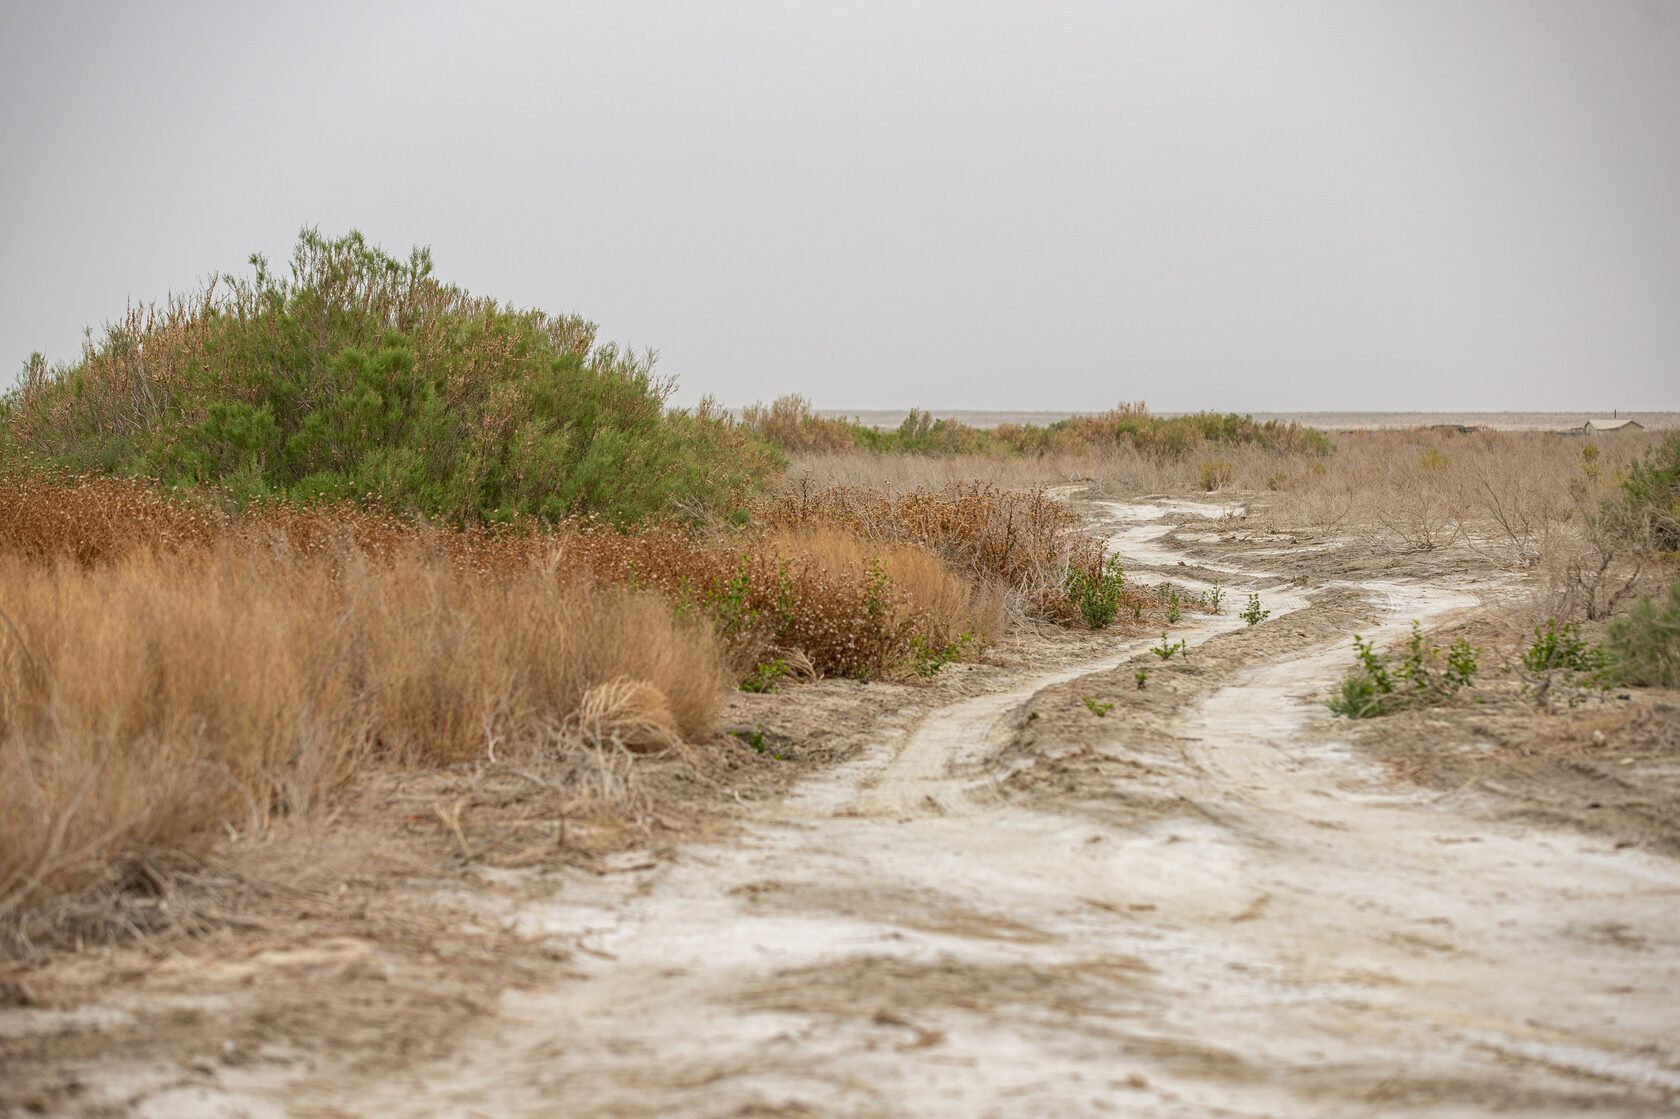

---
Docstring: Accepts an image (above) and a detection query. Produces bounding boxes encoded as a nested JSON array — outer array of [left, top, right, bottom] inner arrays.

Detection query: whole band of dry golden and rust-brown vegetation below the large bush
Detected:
[[0, 475, 1142, 944]]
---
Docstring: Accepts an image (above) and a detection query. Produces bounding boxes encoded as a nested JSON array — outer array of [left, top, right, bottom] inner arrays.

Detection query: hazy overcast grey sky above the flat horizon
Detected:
[[0, 0, 1680, 410]]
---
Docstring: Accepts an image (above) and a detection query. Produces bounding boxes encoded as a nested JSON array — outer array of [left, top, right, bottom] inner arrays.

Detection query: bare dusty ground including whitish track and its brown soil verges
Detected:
[[0, 499, 1680, 1117]]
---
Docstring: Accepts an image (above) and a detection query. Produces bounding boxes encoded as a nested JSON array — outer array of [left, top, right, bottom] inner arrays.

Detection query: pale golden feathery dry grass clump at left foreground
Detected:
[[0, 541, 727, 934]]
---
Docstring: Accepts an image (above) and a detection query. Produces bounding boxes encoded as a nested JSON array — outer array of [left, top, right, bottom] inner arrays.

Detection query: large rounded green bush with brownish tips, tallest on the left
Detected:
[[0, 230, 780, 523]]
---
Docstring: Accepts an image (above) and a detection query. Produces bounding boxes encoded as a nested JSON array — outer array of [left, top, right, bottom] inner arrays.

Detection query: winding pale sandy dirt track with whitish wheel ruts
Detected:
[[16, 502, 1680, 1117]]
